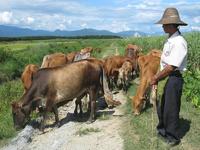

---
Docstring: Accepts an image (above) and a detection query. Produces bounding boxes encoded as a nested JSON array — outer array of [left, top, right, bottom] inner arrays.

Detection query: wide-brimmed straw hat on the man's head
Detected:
[[156, 8, 187, 26]]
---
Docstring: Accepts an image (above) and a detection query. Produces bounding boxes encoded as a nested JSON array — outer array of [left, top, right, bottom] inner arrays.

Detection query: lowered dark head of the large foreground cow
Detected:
[[11, 102, 30, 129]]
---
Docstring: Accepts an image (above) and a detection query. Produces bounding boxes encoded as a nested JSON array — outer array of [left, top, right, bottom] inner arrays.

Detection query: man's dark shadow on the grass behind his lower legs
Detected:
[[179, 118, 191, 139]]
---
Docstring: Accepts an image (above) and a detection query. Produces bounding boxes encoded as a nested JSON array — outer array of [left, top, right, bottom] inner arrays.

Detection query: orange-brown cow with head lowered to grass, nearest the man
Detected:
[[132, 51, 160, 115]]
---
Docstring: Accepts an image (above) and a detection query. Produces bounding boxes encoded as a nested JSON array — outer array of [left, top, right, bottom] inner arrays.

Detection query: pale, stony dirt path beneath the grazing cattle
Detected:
[[3, 91, 126, 150]]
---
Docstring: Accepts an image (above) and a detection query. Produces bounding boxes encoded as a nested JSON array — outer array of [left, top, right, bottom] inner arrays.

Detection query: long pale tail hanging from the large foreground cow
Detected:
[[101, 68, 121, 107]]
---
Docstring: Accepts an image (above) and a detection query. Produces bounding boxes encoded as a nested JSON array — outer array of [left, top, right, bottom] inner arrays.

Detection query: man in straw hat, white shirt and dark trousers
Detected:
[[150, 8, 187, 146]]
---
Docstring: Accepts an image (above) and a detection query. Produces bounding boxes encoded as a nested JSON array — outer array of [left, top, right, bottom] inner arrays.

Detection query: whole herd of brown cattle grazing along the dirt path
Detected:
[[11, 44, 161, 130]]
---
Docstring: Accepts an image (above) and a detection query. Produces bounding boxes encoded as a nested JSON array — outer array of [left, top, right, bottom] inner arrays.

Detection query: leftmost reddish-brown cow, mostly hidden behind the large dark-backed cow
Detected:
[[21, 64, 39, 93]]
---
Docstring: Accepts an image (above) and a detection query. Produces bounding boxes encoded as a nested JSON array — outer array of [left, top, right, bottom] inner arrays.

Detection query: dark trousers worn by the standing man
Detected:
[[157, 73, 183, 140]]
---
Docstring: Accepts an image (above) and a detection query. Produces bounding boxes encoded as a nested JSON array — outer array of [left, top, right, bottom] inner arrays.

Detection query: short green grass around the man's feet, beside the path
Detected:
[[122, 81, 200, 150]]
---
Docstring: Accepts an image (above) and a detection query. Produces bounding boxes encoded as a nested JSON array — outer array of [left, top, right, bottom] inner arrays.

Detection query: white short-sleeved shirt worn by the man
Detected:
[[160, 31, 187, 72]]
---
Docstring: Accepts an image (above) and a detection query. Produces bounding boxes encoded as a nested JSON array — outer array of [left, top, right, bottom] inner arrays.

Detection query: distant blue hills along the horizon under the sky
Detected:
[[0, 25, 146, 37]]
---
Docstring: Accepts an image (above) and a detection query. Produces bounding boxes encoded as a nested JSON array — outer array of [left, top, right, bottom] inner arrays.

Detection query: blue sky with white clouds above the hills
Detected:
[[0, 0, 200, 33]]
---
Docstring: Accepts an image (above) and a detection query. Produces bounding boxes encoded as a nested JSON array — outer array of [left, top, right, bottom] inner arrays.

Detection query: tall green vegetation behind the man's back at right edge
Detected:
[[184, 32, 200, 108]]
